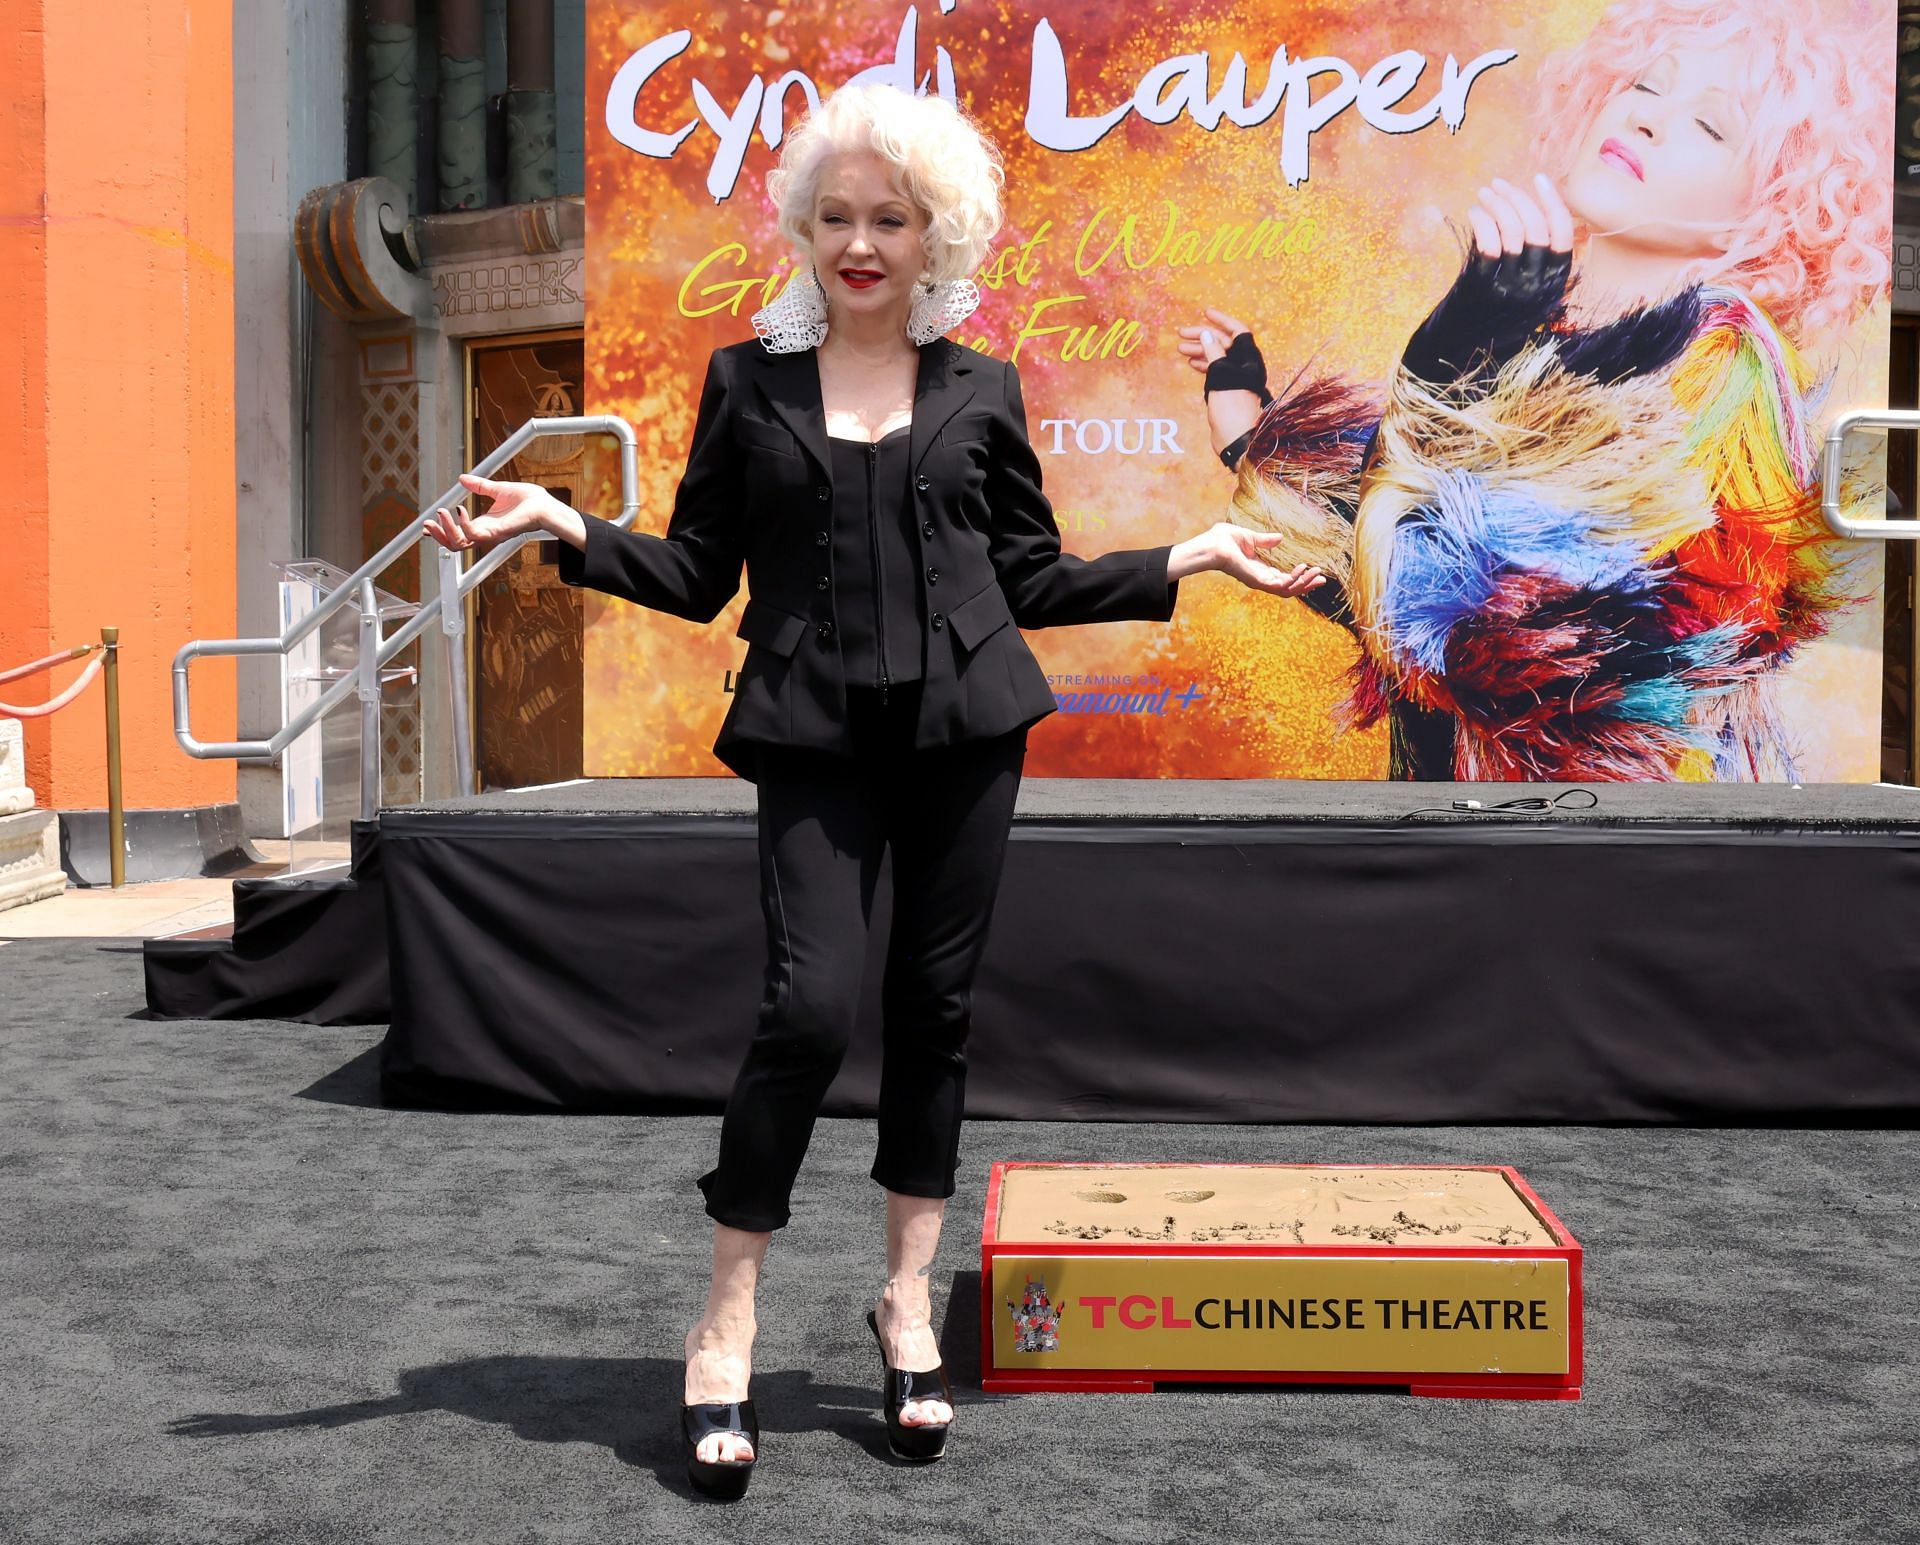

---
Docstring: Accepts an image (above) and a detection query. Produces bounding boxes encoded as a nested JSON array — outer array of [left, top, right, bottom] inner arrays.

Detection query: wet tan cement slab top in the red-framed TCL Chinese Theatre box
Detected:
[[995, 1165, 1555, 1249]]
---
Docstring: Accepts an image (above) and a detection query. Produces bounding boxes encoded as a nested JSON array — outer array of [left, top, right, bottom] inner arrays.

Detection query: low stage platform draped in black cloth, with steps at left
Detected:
[[148, 779, 1920, 1123]]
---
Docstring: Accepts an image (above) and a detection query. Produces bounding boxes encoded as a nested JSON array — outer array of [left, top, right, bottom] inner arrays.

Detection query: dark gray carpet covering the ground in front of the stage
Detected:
[[0, 940, 1920, 1545]]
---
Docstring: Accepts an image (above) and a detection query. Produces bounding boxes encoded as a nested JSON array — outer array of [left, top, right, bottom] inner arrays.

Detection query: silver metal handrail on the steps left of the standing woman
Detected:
[[173, 415, 639, 818]]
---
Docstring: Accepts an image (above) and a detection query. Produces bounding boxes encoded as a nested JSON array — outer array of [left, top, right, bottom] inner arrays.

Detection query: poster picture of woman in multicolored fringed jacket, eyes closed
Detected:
[[1179, 0, 1893, 781]]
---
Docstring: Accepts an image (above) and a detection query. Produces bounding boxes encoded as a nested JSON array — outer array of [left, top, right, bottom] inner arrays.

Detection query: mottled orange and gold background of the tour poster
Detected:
[[586, 0, 1891, 779]]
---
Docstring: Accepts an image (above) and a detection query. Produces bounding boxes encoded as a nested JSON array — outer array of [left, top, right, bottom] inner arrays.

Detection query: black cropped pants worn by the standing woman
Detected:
[[699, 685, 1027, 1232]]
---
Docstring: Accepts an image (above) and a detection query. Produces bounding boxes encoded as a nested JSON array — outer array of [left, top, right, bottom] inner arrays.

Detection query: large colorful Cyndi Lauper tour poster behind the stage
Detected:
[[586, 0, 1895, 781]]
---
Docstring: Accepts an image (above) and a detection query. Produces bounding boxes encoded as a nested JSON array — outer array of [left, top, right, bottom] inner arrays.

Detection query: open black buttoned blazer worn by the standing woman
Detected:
[[561, 338, 1179, 777]]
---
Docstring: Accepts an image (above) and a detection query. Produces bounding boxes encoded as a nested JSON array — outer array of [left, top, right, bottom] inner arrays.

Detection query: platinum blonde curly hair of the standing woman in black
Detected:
[[766, 84, 1006, 284]]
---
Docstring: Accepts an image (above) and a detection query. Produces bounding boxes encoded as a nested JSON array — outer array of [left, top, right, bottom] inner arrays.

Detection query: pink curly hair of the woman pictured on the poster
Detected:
[[1534, 0, 1893, 347]]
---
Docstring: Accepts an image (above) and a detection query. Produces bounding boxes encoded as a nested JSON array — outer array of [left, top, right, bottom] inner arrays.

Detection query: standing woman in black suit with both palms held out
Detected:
[[420, 86, 1321, 1497]]
